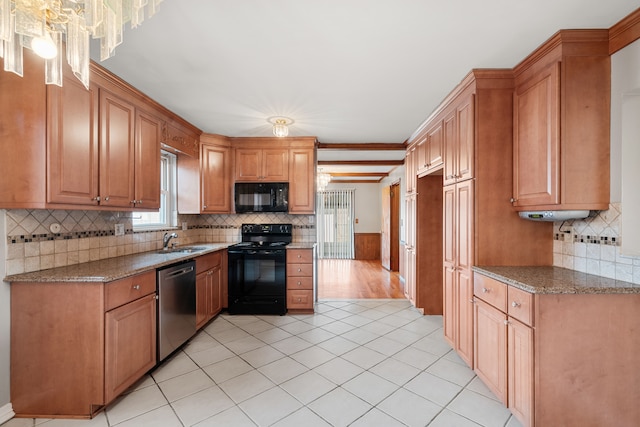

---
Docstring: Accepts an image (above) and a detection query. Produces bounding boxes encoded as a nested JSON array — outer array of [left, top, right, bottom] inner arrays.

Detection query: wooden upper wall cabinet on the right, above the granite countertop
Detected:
[[512, 30, 611, 210]]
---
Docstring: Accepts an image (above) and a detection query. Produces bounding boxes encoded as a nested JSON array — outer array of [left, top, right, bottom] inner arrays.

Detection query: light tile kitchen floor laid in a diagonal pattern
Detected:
[[2, 299, 520, 427]]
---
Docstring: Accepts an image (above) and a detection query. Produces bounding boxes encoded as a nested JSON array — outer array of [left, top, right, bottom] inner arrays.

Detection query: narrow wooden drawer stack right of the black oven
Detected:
[[287, 249, 315, 313]]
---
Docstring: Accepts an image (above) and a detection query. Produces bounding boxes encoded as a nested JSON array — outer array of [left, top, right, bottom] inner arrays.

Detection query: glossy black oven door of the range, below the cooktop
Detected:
[[229, 249, 287, 314]]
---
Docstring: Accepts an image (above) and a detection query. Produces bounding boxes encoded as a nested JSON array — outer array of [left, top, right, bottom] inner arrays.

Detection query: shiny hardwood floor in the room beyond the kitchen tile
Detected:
[[318, 259, 404, 299]]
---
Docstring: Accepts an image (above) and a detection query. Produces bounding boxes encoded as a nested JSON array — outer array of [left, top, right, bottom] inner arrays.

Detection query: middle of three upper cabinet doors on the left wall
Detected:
[[100, 89, 135, 207]]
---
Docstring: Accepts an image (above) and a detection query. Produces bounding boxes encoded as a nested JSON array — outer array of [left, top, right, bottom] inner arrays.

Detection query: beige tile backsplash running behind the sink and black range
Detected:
[[5, 209, 316, 275]]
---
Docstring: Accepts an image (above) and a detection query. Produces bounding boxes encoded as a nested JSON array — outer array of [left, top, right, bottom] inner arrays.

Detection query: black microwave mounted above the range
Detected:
[[234, 182, 289, 213]]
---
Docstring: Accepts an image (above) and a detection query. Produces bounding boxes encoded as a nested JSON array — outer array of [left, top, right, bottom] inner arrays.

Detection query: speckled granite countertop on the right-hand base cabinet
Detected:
[[473, 266, 640, 294]]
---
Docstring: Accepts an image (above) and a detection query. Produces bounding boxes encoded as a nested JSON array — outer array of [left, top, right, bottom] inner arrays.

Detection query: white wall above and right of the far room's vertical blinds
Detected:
[[327, 182, 382, 233]]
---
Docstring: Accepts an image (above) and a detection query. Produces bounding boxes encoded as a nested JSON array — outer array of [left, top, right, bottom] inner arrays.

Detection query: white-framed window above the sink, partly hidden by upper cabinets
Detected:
[[133, 151, 178, 230]]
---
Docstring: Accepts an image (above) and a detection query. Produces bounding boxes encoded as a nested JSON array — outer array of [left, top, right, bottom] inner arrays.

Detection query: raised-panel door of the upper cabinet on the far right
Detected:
[[513, 63, 560, 206]]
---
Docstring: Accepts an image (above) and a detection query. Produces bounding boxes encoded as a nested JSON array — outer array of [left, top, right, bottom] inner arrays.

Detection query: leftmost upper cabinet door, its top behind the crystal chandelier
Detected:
[[47, 75, 98, 205]]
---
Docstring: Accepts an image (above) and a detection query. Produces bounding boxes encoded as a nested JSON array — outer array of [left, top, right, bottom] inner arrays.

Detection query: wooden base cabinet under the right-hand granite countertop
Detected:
[[474, 273, 640, 427]]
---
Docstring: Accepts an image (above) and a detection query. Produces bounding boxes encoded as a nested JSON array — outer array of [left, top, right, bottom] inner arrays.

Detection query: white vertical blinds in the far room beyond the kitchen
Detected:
[[316, 189, 355, 259]]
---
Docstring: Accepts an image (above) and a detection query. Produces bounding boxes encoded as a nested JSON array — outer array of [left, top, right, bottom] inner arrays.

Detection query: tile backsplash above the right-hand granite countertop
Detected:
[[553, 203, 640, 284]]
